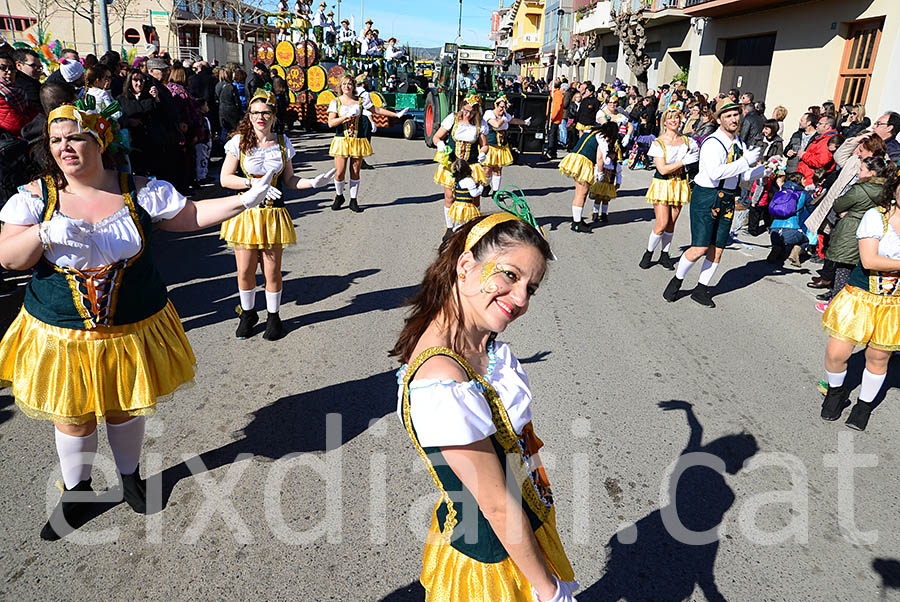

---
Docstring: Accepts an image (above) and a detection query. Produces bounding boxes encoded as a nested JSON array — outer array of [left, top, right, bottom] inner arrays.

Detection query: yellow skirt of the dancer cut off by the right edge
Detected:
[[822, 285, 900, 351]]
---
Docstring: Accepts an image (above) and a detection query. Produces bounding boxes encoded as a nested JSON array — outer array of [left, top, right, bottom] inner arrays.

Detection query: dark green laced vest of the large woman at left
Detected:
[[25, 173, 168, 330]]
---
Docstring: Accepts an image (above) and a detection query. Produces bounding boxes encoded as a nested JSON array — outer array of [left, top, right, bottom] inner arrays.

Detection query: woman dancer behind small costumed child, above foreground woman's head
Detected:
[[432, 90, 488, 238]]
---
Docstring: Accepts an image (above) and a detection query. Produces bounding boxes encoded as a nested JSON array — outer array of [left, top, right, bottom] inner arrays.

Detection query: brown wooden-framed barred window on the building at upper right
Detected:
[[834, 17, 884, 106]]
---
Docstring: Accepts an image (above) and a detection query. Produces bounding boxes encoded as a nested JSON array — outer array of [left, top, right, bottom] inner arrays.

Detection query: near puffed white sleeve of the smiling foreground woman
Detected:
[[409, 379, 497, 447]]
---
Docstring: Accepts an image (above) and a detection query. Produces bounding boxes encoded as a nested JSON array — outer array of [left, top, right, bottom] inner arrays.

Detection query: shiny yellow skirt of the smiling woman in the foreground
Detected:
[[420, 507, 575, 602]]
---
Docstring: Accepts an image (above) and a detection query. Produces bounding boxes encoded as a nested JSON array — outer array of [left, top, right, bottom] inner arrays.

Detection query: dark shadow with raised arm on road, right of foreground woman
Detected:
[[577, 400, 759, 602]]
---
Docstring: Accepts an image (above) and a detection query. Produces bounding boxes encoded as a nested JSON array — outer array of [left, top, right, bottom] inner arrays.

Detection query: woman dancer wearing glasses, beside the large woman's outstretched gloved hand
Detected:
[[219, 84, 334, 341]]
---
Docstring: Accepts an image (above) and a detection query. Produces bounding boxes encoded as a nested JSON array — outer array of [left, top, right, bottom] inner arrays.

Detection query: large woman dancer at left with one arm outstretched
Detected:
[[0, 98, 271, 540]]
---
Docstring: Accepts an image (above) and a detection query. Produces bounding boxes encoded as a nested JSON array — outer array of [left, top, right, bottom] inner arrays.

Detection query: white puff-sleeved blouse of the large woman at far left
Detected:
[[0, 178, 187, 270]]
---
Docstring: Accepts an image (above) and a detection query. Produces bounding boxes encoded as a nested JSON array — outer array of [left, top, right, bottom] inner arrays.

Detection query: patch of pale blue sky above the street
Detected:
[[326, 0, 500, 48]]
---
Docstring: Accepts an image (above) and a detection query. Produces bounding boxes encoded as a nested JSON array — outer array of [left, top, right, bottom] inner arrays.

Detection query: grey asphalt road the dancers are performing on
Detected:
[[0, 130, 900, 602]]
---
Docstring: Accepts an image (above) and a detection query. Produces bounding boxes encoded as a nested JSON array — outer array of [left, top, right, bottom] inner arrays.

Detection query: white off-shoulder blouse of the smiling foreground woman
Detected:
[[397, 343, 531, 447]]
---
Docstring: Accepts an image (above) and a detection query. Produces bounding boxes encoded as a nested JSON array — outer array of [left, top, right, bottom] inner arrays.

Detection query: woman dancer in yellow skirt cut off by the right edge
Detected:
[[821, 173, 900, 431]]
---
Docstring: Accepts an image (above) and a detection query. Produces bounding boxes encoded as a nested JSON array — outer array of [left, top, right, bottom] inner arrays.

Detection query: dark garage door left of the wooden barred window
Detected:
[[719, 33, 775, 100]]
